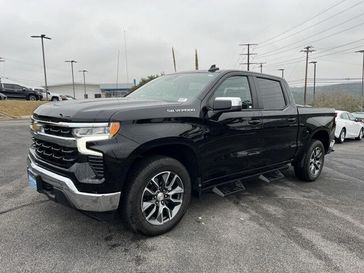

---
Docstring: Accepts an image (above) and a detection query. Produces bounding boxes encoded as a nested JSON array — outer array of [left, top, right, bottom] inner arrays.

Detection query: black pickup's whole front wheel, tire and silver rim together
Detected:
[[120, 156, 191, 236]]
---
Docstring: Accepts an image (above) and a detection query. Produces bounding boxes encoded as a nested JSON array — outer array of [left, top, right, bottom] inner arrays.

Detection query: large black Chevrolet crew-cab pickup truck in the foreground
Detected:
[[28, 68, 335, 235]]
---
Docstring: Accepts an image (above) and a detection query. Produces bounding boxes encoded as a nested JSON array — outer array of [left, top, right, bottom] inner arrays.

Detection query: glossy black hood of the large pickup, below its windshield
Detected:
[[34, 98, 199, 122]]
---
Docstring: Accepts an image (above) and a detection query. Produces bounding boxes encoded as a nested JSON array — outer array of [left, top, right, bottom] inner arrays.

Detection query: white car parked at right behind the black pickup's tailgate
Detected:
[[335, 111, 364, 143]]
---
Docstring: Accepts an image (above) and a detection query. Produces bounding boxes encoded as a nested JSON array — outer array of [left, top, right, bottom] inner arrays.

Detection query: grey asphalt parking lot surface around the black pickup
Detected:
[[0, 121, 364, 273]]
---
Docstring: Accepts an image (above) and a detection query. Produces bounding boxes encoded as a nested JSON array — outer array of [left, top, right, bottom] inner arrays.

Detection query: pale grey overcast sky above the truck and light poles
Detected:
[[0, 0, 364, 86]]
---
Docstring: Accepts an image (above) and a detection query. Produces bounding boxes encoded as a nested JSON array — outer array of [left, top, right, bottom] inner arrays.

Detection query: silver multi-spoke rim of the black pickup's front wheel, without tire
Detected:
[[141, 171, 184, 225]]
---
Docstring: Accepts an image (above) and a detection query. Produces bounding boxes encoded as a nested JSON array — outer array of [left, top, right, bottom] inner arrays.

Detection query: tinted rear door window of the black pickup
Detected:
[[256, 78, 286, 110]]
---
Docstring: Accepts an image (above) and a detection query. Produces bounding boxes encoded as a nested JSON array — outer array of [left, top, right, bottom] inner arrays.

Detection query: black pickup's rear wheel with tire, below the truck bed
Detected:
[[294, 140, 325, 182]]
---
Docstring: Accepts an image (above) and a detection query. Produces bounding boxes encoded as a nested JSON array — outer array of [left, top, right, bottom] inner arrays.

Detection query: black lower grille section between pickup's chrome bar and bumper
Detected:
[[33, 138, 78, 168]]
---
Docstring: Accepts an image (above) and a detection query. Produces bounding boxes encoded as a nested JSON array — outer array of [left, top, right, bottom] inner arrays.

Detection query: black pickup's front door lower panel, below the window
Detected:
[[199, 110, 264, 180]]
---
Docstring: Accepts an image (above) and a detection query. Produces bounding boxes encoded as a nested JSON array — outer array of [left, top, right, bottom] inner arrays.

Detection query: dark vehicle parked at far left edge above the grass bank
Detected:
[[0, 83, 42, 100]]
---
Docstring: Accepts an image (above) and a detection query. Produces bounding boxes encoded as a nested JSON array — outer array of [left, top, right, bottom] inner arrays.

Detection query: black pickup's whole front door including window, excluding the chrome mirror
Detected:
[[199, 72, 264, 181]]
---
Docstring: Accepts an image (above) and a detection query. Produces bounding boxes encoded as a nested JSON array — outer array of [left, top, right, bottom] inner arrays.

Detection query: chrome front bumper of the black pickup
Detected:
[[28, 156, 121, 212]]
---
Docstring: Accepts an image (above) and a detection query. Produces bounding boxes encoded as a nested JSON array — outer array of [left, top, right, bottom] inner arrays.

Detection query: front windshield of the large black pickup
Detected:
[[127, 72, 217, 102]]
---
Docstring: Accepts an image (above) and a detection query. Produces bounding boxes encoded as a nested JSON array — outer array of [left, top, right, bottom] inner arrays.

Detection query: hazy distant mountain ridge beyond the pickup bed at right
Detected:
[[290, 82, 361, 104]]
